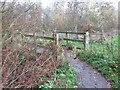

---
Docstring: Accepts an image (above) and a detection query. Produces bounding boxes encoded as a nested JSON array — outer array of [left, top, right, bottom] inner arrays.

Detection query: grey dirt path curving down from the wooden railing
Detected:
[[65, 51, 110, 88]]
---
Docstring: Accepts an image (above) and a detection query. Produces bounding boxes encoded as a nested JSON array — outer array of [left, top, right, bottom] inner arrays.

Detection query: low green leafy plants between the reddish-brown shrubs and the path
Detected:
[[39, 57, 78, 88]]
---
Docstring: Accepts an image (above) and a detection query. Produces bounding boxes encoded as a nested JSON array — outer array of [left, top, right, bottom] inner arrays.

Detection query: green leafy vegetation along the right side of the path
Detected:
[[77, 37, 120, 88]]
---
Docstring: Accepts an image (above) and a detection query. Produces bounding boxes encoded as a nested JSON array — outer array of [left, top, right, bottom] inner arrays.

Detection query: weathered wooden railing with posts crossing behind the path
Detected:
[[19, 32, 89, 50]]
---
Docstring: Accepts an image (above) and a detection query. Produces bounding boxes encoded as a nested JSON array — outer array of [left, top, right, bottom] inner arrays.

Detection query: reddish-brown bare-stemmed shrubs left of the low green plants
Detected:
[[2, 43, 61, 88]]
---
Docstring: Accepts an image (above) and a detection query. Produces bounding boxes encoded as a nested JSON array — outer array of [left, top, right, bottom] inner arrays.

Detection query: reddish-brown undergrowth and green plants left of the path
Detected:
[[2, 34, 77, 88]]
